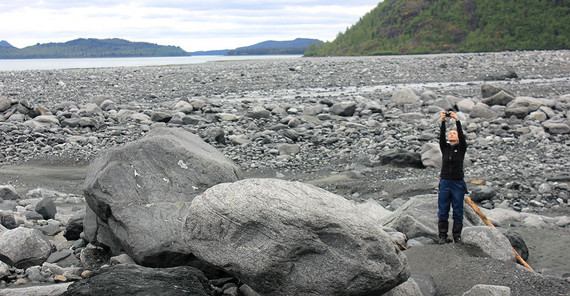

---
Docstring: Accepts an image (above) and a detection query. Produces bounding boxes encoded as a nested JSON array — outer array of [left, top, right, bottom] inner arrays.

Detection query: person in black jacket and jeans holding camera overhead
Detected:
[[437, 111, 467, 244]]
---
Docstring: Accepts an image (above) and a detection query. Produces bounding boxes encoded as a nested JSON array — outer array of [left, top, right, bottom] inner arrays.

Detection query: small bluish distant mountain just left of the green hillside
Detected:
[[227, 38, 322, 55]]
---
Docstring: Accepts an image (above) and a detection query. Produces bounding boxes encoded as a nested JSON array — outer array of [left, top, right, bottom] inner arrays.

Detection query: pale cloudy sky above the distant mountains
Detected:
[[0, 0, 379, 52]]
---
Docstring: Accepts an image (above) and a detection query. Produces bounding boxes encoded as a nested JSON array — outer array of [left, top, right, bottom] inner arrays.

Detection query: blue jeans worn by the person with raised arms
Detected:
[[437, 179, 467, 223]]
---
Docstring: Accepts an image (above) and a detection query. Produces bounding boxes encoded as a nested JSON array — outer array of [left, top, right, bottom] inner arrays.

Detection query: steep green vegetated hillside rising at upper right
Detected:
[[305, 0, 570, 56]]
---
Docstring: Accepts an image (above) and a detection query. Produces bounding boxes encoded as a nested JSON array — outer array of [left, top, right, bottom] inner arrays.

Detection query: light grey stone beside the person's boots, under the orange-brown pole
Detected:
[[461, 226, 515, 262]]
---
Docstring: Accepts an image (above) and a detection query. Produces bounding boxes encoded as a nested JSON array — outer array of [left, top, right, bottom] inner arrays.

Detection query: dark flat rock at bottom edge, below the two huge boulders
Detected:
[[61, 264, 213, 296]]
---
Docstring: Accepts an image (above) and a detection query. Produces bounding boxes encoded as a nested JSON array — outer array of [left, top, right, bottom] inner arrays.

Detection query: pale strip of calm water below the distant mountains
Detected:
[[0, 55, 301, 71]]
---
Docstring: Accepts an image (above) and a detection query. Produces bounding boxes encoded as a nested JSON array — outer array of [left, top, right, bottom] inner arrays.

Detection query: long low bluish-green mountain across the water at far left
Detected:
[[0, 38, 190, 59]]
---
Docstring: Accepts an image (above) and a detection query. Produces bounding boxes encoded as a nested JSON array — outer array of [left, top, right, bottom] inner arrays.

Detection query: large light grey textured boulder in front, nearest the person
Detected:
[[183, 179, 410, 295]]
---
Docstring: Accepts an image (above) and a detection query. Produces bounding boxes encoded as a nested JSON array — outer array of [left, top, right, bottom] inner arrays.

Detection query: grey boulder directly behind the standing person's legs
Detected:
[[380, 194, 483, 239]]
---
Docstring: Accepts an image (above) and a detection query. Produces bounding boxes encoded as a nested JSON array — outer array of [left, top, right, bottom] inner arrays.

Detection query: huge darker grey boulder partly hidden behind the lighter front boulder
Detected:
[[83, 128, 241, 266]]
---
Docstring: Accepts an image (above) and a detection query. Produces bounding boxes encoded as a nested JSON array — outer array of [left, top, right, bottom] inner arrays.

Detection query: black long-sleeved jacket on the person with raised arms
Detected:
[[439, 121, 467, 180]]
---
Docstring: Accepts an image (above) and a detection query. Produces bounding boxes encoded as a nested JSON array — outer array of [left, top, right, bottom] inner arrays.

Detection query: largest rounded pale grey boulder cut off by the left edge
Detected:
[[0, 228, 52, 268]]
